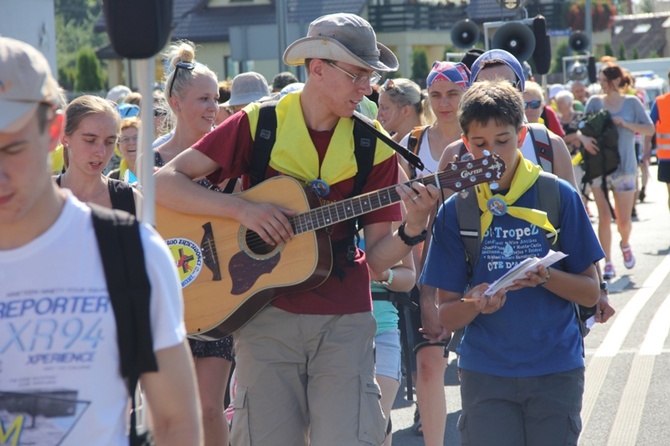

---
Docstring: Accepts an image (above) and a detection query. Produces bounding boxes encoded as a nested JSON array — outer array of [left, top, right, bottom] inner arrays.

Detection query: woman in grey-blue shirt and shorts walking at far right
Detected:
[[580, 63, 655, 279]]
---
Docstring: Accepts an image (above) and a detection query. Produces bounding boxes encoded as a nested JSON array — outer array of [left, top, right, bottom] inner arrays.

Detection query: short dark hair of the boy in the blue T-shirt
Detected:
[[458, 81, 524, 135]]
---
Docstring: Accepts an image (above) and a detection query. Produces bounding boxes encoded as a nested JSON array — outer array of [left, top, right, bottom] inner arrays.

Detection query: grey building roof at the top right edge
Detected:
[[612, 12, 670, 59]]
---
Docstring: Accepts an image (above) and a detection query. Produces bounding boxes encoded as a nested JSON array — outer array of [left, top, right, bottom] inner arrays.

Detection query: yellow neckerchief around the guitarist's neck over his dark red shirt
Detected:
[[244, 92, 393, 185]]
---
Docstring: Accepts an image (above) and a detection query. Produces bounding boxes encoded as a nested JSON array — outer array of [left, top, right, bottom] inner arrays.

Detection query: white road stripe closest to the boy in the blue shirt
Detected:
[[582, 256, 670, 432]]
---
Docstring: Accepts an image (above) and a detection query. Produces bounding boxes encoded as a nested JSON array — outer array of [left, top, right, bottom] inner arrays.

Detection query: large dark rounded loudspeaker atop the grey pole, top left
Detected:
[[102, 0, 173, 59]]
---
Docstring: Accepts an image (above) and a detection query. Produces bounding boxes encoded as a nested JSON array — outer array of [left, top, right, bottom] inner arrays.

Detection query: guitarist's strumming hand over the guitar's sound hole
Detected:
[[240, 200, 296, 245]]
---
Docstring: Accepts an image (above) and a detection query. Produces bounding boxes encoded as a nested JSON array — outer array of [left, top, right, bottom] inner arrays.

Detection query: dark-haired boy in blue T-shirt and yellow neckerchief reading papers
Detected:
[[421, 81, 604, 446]]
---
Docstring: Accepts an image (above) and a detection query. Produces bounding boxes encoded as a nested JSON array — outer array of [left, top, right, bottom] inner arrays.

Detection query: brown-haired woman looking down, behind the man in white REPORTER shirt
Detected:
[[56, 95, 142, 214]]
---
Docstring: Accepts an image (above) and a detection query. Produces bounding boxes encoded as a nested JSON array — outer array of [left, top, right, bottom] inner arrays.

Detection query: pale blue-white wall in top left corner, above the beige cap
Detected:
[[0, 0, 57, 76]]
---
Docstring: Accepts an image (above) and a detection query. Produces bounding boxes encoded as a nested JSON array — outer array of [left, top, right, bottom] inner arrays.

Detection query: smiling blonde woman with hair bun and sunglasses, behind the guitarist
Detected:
[[154, 41, 233, 446]]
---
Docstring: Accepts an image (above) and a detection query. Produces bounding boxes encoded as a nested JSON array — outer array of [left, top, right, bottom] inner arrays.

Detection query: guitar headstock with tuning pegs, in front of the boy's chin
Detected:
[[436, 154, 505, 192]]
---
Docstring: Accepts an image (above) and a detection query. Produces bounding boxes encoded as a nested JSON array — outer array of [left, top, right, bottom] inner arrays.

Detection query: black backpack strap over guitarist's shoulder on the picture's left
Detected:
[[248, 101, 277, 186]]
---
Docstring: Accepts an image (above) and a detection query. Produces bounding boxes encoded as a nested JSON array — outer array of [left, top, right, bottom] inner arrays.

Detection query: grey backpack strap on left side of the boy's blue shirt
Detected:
[[456, 187, 481, 279]]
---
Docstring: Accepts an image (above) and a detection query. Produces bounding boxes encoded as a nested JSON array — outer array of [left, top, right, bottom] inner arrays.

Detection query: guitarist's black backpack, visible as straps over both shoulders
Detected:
[[248, 101, 377, 279]]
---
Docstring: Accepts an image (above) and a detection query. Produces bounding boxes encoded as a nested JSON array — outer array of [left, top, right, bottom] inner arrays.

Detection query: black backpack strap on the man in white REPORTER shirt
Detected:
[[89, 204, 158, 446]]
